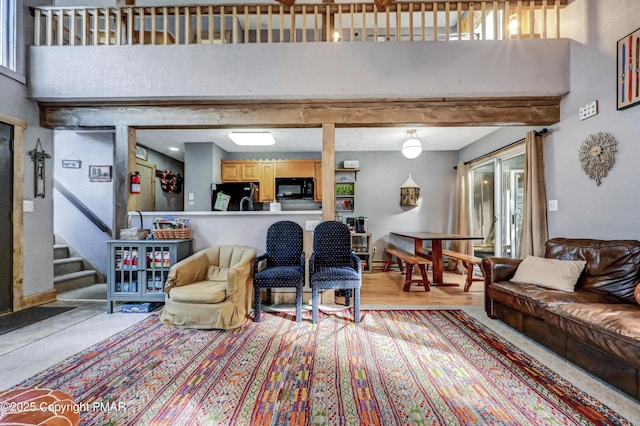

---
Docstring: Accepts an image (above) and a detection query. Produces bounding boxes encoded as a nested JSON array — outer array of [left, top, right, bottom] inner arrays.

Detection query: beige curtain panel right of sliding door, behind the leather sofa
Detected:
[[520, 130, 549, 258]]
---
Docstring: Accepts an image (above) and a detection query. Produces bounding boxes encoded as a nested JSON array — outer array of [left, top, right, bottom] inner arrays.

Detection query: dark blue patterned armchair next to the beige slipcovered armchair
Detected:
[[253, 220, 304, 322]]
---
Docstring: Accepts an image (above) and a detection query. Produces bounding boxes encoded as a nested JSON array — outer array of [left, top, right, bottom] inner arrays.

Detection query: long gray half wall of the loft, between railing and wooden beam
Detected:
[[29, 39, 569, 101]]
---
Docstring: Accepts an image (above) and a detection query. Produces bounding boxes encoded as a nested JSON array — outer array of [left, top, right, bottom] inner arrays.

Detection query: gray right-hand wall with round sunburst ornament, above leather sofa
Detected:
[[459, 0, 640, 239]]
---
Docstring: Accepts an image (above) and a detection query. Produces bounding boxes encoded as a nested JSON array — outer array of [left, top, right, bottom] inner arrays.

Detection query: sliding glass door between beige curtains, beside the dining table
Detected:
[[471, 148, 524, 258]]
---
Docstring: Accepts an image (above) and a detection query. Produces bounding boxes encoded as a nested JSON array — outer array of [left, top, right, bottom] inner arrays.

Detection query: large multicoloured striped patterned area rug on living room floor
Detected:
[[16, 310, 631, 426]]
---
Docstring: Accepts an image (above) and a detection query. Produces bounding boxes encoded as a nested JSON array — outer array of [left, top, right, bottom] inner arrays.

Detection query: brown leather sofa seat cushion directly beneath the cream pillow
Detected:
[[486, 281, 623, 319]]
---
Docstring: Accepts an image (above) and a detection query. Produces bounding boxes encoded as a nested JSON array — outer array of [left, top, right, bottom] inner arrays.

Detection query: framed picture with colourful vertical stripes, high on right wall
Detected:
[[616, 28, 640, 110]]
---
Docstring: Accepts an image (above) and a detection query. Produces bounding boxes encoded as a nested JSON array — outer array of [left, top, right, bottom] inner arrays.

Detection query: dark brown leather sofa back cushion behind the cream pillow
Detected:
[[544, 238, 640, 303]]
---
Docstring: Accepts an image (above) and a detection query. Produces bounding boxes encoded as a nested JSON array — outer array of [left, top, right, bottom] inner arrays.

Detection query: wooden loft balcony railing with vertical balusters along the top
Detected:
[[33, 0, 567, 46]]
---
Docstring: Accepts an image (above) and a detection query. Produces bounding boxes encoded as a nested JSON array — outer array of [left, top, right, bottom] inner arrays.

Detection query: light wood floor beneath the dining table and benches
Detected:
[[360, 270, 484, 306]]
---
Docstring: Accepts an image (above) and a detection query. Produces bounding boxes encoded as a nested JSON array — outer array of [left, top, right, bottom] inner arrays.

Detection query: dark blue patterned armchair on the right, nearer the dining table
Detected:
[[309, 221, 362, 324]]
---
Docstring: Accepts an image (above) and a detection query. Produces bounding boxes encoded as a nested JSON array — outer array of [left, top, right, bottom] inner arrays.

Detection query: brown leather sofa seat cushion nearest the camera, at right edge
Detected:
[[544, 303, 640, 368]]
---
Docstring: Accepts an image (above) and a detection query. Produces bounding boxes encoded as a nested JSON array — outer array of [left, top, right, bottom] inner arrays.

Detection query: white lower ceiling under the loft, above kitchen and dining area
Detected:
[[136, 127, 500, 161]]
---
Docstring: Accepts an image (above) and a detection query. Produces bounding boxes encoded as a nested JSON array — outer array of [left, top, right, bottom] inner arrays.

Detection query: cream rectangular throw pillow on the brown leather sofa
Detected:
[[511, 256, 587, 291]]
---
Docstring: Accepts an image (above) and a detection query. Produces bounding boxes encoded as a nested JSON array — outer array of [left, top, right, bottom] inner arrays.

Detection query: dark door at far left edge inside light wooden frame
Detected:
[[0, 122, 13, 313]]
